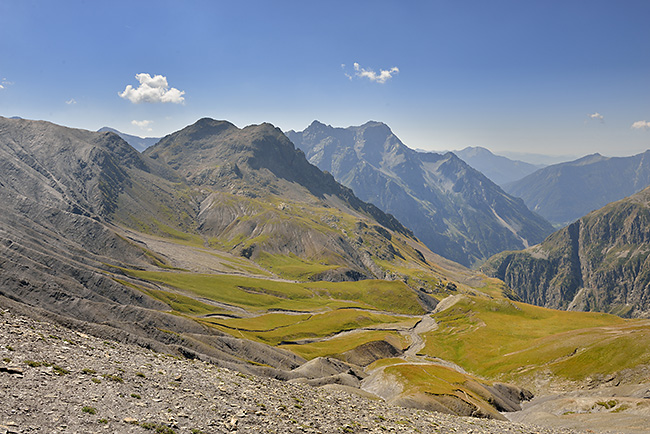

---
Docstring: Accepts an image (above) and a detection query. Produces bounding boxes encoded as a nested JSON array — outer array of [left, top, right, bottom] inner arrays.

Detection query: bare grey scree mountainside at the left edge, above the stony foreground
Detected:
[[0, 118, 300, 376]]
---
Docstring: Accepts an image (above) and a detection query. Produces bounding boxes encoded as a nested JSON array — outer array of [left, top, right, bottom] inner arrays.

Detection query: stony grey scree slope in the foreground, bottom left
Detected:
[[0, 305, 576, 434]]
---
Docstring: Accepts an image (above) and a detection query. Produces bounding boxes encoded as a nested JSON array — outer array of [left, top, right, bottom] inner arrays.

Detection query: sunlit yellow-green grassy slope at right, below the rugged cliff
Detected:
[[422, 297, 650, 384]]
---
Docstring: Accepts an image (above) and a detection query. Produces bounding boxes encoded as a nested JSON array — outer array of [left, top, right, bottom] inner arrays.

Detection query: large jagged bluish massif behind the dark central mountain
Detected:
[[286, 121, 552, 265]]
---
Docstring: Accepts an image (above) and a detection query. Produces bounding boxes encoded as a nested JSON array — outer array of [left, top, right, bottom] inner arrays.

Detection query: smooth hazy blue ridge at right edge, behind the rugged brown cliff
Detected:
[[503, 151, 650, 224]]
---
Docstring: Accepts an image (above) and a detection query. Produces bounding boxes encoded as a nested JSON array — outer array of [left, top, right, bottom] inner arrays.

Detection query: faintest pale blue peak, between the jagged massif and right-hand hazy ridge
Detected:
[[452, 146, 544, 185]]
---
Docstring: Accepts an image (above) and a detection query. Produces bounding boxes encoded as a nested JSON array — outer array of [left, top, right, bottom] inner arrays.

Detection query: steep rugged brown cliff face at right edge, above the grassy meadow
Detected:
[[483, 188, 650, 317]]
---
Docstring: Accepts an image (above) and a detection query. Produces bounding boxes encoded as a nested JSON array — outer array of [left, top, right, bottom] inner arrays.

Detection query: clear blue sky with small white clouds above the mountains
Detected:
[[0, 0, 650, 155]]
